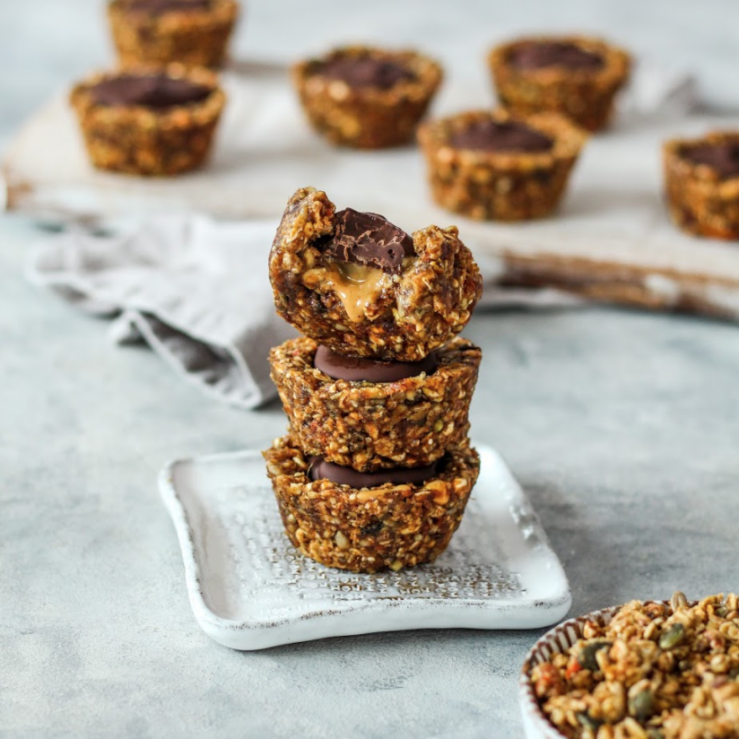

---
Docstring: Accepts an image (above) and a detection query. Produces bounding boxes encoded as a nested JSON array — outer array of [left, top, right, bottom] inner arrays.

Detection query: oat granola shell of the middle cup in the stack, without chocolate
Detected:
[[270, 338, 482, 472]]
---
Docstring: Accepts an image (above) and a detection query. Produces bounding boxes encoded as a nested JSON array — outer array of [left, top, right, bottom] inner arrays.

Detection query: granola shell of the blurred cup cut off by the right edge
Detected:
[[663, 131, 739, 240]]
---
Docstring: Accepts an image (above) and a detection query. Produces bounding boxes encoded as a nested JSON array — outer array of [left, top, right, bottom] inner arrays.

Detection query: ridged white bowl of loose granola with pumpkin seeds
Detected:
[[519, 593, 739, 739]]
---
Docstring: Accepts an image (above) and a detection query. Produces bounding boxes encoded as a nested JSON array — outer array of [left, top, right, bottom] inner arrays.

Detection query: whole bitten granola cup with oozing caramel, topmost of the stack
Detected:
[[269, 188, 482, 362]]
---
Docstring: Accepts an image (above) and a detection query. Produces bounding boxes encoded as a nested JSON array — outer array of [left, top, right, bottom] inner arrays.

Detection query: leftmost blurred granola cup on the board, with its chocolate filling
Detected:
[[70, 64, 226, 175]]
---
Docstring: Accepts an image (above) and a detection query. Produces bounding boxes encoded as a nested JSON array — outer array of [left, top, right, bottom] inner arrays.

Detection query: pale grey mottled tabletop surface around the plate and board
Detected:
[[0, 0, 739, 739]]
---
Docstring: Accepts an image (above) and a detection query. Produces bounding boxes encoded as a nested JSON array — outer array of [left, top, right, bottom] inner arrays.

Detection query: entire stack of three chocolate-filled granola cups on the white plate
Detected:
[[264, 188, 482, 572]]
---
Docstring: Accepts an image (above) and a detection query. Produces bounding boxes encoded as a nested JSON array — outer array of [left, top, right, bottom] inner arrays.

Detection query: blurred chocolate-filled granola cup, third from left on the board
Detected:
[[292, 46, 442, 149]]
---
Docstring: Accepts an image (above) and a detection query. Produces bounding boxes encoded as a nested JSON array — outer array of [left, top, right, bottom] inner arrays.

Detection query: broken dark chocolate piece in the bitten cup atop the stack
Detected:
[[317, 208, 415, 274]]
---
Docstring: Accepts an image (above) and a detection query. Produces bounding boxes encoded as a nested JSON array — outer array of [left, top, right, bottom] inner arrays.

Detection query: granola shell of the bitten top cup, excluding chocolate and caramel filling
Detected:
[[269, 188, 482, 362]]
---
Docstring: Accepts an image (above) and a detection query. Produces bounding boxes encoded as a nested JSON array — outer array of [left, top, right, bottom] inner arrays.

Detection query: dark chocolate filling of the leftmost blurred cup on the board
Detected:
[[90, 73, 212, 110]]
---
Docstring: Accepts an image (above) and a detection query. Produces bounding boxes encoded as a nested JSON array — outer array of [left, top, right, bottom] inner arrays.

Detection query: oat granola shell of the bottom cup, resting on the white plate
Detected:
[[264, 434, 480, 572]]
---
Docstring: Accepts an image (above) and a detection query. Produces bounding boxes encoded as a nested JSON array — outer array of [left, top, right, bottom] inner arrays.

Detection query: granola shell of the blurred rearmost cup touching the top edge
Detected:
[[108, 0, 239, 67]]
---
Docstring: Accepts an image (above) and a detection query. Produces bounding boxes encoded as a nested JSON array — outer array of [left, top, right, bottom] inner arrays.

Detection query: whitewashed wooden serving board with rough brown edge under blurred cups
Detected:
[[3, 64, 739, 320]]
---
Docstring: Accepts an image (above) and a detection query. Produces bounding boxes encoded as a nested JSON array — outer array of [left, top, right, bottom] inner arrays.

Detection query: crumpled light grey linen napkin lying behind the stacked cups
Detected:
[[27, 216, 295, 408]]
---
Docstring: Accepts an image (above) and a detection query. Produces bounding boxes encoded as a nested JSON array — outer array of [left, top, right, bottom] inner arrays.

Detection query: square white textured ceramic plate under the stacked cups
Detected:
[[159, 446, 571, 649]]
